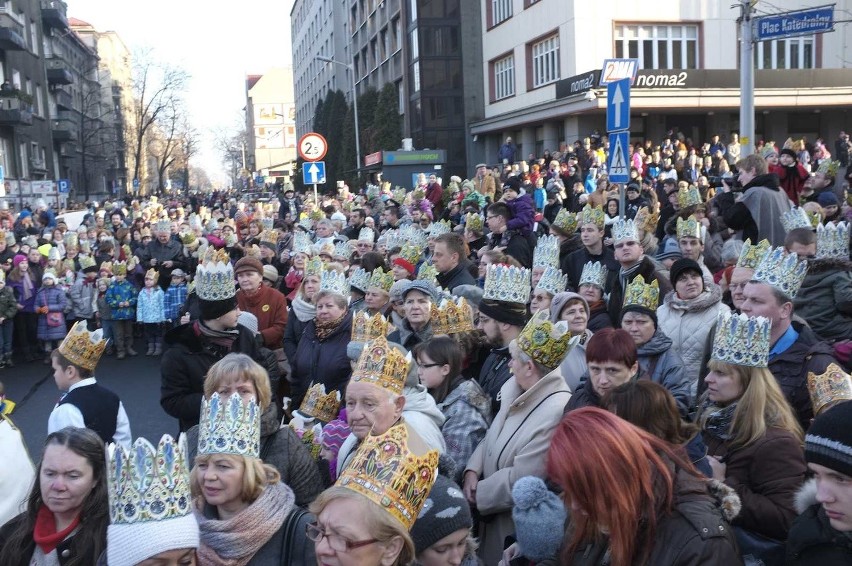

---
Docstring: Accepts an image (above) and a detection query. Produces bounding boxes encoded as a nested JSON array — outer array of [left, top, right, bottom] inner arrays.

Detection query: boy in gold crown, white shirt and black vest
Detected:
[[47, 321, 132, 447]]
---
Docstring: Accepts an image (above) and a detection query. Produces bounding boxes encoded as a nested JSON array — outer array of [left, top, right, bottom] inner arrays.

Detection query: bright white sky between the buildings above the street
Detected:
[[66, 0, 294, 184]]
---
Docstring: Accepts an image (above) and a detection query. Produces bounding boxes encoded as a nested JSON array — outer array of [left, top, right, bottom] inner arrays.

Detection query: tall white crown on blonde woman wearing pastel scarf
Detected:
[[198, 393, 260, 458]]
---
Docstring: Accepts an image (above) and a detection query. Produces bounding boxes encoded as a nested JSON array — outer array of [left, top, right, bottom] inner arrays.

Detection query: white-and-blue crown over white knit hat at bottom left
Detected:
[[107, 434, 192, 525]]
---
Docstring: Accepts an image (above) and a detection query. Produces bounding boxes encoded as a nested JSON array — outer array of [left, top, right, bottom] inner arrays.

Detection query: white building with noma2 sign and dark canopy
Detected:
[[470, 0, 852, 163]]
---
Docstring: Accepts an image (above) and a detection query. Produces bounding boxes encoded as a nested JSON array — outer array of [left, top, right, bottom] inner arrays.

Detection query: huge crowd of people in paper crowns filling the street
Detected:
[[0, 132, 852, 566]]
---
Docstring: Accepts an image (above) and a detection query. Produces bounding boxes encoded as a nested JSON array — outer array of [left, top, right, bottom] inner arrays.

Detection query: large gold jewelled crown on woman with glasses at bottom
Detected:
[[337, 424, 438, 531]]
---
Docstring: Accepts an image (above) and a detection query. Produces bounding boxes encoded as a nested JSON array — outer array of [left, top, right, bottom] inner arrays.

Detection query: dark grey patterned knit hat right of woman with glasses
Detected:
[[411, 475, 473, 554]]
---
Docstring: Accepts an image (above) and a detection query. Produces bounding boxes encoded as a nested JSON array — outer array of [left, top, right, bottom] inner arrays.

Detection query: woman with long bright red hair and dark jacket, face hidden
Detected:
[[547, 407, 742, 566]]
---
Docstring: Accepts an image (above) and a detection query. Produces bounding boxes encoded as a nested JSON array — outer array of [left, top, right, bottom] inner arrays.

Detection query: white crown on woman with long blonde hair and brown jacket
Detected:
[[710, 312, 772, 368]]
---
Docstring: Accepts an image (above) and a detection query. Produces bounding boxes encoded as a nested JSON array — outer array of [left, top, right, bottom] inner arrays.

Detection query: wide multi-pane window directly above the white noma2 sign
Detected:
[[615, 24, 698, 69]]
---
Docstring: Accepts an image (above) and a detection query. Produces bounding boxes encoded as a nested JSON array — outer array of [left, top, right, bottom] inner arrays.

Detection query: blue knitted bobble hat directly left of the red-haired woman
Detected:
[[512, 476, 568, 562]]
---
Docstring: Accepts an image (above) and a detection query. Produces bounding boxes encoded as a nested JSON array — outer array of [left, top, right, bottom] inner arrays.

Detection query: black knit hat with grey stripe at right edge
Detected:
[[805, 401, 852, 477]]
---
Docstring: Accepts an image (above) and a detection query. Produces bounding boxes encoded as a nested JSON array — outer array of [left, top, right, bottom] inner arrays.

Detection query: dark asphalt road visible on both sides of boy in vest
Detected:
[[0, 340, 178, 461]]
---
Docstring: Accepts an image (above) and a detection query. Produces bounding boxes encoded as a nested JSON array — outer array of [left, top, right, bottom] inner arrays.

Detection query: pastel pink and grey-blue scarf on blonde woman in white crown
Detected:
[[195, 482, 295, 566]]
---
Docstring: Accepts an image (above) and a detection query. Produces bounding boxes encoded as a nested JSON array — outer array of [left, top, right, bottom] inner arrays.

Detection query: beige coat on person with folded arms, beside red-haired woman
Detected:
[[467, 368, 571, 564]]
